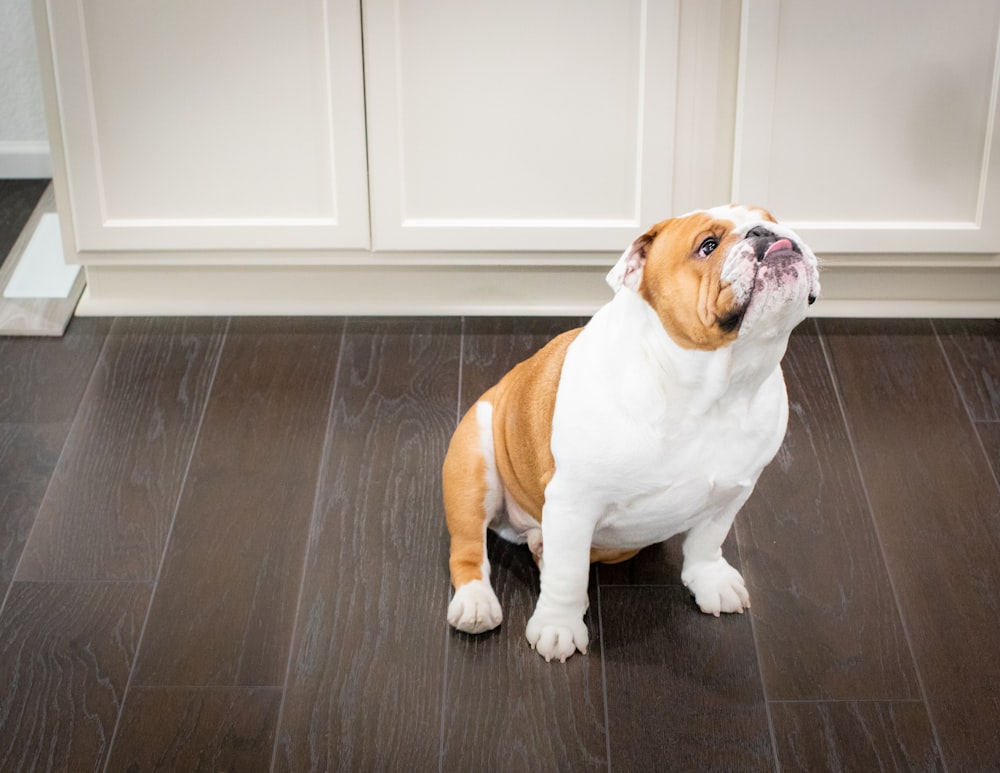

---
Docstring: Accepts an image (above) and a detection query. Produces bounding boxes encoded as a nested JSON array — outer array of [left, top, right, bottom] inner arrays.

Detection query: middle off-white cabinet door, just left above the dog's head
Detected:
[[364, 0, 678, 251]]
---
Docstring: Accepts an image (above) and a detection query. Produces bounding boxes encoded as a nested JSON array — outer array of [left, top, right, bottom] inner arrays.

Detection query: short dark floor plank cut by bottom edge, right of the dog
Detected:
[[771, 701, 944, 773]]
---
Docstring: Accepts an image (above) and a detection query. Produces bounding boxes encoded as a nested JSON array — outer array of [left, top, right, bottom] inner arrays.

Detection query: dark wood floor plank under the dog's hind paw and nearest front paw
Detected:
[[442, 319, 607, 770]]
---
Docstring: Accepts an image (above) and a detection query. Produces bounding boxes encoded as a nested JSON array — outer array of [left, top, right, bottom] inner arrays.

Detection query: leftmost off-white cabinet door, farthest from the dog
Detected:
[[44, 0, 369, 250]]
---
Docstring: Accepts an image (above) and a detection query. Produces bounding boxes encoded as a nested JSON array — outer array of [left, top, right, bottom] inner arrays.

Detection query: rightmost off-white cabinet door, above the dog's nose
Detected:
[[734, 0, 1000, 253]]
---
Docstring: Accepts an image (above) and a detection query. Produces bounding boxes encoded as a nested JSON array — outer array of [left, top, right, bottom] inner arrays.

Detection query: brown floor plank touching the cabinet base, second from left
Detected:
[[17, 319, 226, 581]]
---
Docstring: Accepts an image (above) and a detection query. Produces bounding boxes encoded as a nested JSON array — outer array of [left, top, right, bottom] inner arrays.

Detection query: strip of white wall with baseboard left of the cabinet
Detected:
[[0, 0, 52, 178]]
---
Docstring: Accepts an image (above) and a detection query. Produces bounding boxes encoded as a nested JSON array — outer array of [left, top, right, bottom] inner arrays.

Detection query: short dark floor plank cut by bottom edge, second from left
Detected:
[[107, 687, 281, 773]]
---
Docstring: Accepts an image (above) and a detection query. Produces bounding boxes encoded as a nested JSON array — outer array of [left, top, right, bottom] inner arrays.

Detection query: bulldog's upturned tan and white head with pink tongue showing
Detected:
[[608, 205, 819, 350]]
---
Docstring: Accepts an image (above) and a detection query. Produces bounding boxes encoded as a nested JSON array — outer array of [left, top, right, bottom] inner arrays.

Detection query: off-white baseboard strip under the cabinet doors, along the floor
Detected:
[[77, 265, 1000, 317]]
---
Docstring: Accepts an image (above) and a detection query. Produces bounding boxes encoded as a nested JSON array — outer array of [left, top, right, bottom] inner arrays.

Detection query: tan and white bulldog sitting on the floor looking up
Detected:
[[443, 206, 819, 661]]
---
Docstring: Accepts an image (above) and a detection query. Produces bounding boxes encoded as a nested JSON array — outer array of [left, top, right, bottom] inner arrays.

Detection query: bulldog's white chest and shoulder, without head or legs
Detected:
[[546, 290, 788, 549]]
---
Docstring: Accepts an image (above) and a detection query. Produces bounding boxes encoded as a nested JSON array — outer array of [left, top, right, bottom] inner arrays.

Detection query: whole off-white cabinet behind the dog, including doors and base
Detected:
[[34, 0, 1000, 315]]
